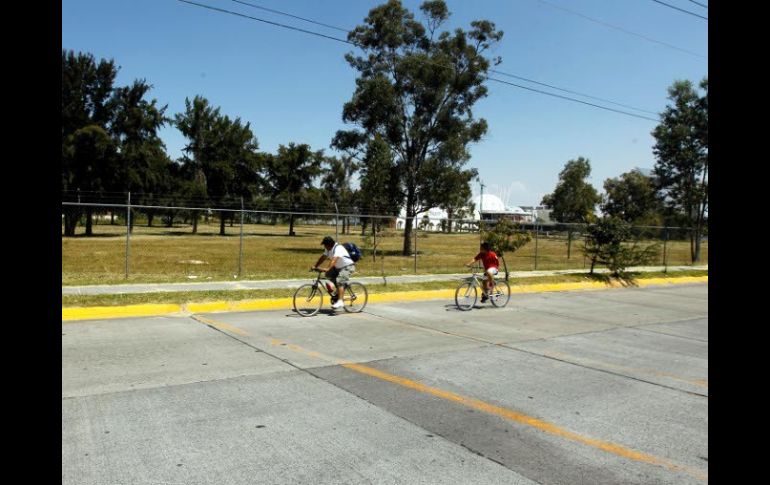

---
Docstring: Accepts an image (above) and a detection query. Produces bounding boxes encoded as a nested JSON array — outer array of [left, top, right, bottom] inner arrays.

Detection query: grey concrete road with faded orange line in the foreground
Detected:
[[62, 284, 708, 485]]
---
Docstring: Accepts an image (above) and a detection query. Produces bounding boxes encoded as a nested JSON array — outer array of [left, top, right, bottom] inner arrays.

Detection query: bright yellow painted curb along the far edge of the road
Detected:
[[62, 276, 708, 321]]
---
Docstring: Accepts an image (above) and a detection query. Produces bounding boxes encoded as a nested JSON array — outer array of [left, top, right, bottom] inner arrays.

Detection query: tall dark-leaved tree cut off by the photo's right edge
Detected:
[[652, 78, 708, 263]]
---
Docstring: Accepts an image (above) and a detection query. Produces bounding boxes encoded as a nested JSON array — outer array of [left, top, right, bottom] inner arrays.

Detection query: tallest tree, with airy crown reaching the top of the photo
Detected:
[[332, 0, 503, 255]]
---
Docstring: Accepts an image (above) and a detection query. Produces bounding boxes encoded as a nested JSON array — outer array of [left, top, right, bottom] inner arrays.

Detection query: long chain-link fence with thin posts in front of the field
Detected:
[[62, 198, 708, 285]]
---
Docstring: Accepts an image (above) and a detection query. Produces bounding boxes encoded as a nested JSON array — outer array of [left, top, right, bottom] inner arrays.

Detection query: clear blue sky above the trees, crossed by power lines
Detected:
[[62, 0, 708, 205]]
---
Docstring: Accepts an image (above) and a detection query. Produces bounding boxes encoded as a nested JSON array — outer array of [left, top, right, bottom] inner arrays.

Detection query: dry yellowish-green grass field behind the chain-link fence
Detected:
[[62, 222, 708, 285]]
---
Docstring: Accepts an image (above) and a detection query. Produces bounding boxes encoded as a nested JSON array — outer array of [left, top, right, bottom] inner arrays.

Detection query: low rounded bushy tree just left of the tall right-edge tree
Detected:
[[601, 170, 663, 225]]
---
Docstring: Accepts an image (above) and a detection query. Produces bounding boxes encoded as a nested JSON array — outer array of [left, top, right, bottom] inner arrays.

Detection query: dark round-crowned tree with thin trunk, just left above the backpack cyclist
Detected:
[[266, 143, 324, 236]]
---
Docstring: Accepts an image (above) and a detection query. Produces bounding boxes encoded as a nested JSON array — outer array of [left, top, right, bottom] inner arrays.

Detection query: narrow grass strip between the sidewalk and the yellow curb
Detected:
[[62, 270, 708, 307]]
